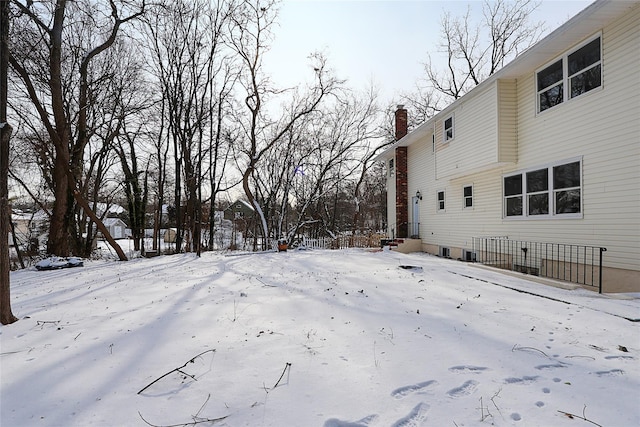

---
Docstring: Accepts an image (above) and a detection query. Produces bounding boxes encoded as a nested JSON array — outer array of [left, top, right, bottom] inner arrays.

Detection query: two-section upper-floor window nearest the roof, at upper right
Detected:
[[536, 36, 602, 112]]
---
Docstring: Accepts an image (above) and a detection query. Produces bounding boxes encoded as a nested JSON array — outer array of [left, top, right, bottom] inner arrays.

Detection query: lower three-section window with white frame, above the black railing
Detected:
[[503, 160, 582, 218]]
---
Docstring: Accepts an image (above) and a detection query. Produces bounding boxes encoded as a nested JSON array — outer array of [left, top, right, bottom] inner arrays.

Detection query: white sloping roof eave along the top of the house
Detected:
[[375, 0, 640, 160]]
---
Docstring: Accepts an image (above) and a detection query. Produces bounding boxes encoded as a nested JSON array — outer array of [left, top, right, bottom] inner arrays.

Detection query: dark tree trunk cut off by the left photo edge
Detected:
[[0, 1, 18, 325]]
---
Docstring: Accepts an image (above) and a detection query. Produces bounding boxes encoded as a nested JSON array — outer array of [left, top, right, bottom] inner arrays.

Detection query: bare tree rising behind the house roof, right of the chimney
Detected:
[[404, 0, 544, 118]]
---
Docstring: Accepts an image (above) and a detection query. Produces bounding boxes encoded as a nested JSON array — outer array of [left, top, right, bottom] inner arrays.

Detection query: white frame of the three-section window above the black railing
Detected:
[[502, 157, 584, 221]]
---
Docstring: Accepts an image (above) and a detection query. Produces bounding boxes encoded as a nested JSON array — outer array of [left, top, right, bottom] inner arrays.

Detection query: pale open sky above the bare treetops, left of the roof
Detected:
[[265, 0, 591, 101]]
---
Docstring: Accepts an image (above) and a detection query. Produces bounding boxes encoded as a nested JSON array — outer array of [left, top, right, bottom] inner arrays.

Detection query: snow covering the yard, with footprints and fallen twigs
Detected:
[[0, 250, 640, 427]]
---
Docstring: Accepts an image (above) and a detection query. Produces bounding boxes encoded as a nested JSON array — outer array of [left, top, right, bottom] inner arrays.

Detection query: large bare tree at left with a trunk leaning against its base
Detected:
[[9, 0, 144, 259]]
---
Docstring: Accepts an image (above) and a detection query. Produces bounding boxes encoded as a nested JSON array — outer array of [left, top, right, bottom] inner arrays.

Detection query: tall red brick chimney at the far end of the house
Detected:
[[395, 105, 409, 238]]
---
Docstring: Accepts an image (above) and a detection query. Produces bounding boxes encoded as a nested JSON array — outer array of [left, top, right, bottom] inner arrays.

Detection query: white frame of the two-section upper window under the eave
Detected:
[[534, 32, 604, 114]]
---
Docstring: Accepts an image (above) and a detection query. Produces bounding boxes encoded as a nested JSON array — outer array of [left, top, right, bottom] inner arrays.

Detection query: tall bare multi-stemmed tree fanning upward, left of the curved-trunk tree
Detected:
[[147, 1, 234, 253]]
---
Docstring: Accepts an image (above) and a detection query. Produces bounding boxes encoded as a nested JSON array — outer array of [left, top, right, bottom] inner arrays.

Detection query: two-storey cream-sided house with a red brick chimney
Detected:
[[378, 0, 640, 292]]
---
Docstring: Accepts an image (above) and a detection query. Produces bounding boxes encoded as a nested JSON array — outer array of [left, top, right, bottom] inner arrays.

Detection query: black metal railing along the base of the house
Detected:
[[473, 236, 607, 293]]
